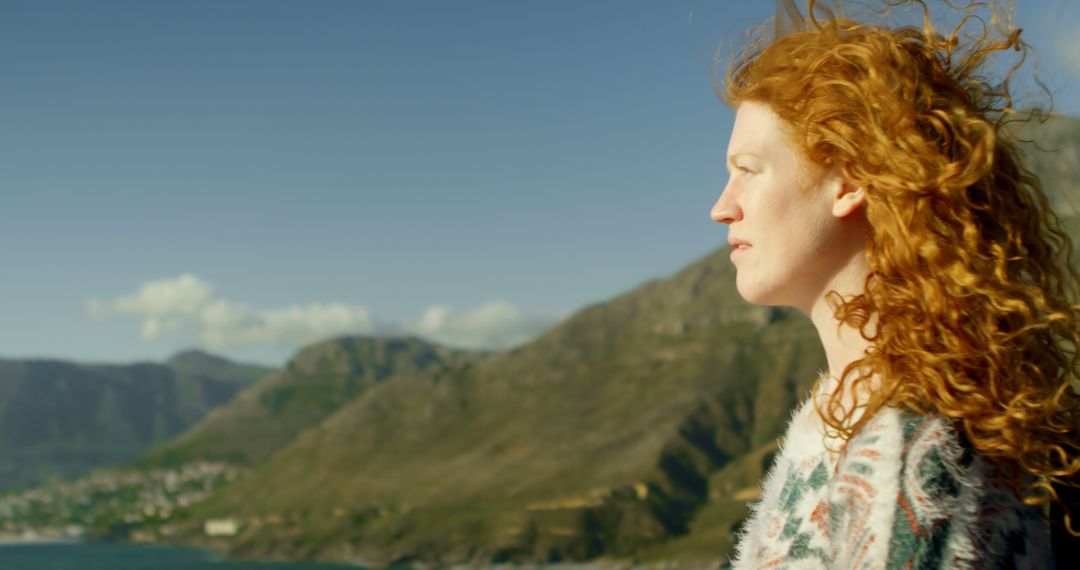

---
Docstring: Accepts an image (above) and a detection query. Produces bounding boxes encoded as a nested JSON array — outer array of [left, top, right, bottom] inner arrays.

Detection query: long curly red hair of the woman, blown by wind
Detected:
[[723, 0, 1080, 516]]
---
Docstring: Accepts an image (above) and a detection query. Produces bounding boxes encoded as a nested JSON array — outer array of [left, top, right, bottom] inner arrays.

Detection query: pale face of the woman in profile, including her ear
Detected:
[[711, 100, 867, 313]]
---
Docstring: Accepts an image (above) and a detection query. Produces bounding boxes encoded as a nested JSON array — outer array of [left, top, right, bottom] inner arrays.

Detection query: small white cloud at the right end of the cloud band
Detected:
[[406, 301, 559, 350]]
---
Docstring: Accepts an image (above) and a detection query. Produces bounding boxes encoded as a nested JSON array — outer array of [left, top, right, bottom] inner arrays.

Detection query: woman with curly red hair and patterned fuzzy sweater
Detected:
[[712, 0, 1080, 568]]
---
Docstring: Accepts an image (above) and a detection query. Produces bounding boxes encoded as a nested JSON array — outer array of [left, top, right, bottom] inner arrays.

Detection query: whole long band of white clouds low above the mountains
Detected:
[[86, 274, 562, 351]]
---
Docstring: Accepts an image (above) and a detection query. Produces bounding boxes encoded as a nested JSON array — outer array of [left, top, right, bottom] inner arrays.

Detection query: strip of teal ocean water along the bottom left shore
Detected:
[[0, 542, 360, 570]]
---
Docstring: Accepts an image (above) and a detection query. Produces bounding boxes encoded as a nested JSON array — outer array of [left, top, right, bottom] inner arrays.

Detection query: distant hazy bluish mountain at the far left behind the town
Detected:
[[0, 352, 269, 489]]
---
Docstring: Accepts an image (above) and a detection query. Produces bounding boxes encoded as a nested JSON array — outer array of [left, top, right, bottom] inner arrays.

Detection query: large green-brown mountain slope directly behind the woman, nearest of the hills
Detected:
[[177, 250, 824, 562]]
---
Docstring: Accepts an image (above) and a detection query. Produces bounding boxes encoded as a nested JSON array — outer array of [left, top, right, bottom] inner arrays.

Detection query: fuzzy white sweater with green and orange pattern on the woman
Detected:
[[732, 401, 1054, 569]]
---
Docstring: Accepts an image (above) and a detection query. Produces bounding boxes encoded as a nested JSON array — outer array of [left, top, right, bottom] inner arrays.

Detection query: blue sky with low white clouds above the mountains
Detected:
[[0, 0, 1080, 365]]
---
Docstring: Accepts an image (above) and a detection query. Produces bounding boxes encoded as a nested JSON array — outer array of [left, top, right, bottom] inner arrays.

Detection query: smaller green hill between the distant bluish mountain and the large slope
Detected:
[[140, 337, 473, 466]]
